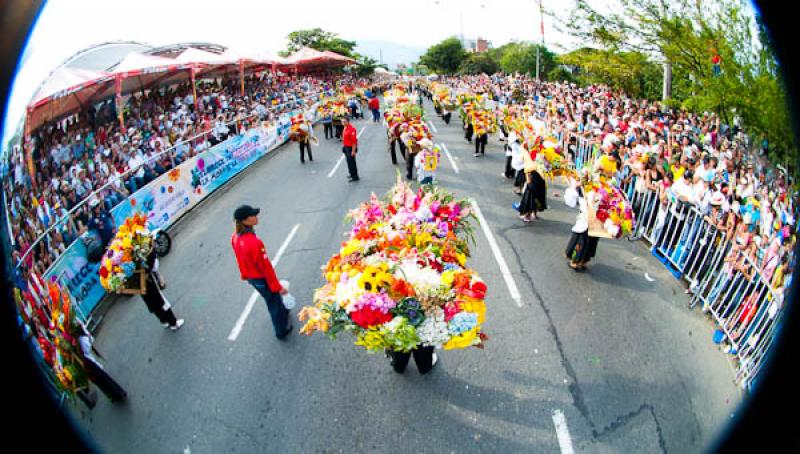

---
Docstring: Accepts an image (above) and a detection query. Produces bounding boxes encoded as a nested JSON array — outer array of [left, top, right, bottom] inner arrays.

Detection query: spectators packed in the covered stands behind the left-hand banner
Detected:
[[4, 73, 366, 274]]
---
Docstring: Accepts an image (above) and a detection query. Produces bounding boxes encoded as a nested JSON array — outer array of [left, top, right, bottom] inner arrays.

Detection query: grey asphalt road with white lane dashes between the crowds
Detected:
[[74, 99, 739, 453]]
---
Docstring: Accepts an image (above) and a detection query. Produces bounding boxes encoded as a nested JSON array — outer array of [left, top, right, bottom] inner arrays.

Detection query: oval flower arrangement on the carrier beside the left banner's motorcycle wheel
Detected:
[[99, 213, 153, 293]]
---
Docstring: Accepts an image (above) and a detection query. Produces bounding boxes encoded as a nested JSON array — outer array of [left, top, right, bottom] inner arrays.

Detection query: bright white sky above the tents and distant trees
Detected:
[[3, 0, 584, 144]]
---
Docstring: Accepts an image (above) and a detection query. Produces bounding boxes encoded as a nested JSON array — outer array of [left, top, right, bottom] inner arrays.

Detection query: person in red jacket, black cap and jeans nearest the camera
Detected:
[[231, 205, 292, 340]]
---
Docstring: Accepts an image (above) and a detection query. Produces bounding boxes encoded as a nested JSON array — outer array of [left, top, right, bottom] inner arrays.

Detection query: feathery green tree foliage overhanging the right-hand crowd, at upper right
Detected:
[[561, 0, 798, 168]]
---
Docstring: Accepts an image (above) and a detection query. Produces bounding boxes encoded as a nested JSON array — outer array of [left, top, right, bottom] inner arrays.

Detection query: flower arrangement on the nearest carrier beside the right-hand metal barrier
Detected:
[[583, 177, 635, 239]]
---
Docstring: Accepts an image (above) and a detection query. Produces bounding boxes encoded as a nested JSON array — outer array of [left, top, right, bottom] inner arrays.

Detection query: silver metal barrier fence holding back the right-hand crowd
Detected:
[[620, 174, 782, 388]]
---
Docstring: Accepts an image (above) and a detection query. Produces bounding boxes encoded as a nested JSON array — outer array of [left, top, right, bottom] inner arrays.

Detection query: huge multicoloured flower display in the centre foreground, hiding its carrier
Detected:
[[299, 178, 488, 352]]
